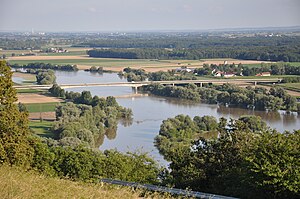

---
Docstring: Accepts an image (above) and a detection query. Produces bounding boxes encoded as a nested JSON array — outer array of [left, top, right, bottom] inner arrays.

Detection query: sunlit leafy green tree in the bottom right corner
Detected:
[[245, 130, 300, 198]]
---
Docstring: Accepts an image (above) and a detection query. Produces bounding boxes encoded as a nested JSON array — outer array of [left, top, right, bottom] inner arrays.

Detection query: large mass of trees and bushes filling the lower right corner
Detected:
[[155, 115, 300, 198]]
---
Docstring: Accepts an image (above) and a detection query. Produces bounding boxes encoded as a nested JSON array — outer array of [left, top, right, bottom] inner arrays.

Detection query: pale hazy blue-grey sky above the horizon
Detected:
[[0, 0, 300, 31]]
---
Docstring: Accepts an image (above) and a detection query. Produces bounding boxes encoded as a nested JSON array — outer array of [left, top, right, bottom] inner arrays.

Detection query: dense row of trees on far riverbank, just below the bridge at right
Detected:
[[142, 84, 299, 111]]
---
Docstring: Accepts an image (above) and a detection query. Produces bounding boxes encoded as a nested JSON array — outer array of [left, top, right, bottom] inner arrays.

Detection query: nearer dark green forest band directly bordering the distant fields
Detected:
[[87, 47, 300, 62]]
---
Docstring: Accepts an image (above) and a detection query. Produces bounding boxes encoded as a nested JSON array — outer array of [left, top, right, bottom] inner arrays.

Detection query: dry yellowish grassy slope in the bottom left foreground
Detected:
[[0, 166, 145, 199]]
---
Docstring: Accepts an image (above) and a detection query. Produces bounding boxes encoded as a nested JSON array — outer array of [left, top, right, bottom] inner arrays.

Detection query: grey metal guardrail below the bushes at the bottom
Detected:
[[100, 178, 237, 199]]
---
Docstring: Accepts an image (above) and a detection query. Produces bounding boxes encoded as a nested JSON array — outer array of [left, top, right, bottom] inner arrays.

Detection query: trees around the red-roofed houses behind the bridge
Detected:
[[118, 63, 300, 83]]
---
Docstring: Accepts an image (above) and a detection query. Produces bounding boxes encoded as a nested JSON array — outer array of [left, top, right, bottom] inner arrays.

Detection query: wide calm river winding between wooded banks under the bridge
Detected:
[[48, 71, 300, 164]]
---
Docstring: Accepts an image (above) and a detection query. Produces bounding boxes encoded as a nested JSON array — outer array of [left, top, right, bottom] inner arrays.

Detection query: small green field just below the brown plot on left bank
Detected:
[[29, 121, 55, 138]]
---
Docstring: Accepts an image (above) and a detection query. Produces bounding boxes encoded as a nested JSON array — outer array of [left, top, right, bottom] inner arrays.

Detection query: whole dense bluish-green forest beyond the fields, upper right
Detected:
[[86, 37, 300, 62]]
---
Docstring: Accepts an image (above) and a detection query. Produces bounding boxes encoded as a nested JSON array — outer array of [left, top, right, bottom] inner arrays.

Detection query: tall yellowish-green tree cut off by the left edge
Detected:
[[0, 61, 33, 166]]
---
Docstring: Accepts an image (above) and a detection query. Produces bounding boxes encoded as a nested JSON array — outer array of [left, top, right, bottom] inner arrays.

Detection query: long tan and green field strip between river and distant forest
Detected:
[[8, 54, 272, 72]]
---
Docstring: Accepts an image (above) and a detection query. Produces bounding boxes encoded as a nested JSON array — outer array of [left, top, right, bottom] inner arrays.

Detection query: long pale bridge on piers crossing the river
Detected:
[[13, 78, 282, 89]]
